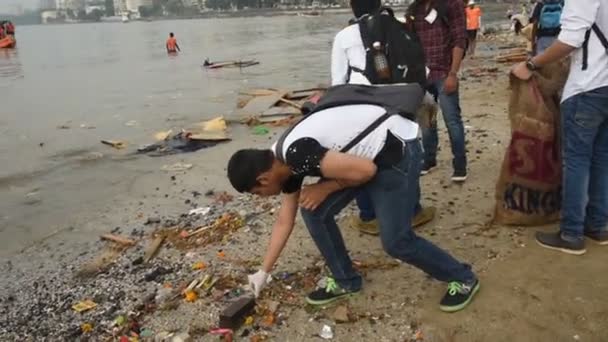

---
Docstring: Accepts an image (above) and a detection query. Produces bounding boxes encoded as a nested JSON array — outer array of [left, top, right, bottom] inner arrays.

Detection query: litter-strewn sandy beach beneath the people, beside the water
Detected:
[[0, 16, 608, 342]]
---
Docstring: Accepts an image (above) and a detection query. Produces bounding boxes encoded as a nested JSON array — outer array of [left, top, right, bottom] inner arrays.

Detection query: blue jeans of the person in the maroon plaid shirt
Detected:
[[422, 80, 467, 171]]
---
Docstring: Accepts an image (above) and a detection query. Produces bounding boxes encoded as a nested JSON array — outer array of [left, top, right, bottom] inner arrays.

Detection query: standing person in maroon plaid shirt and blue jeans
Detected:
[[406, 0, 467, 182]]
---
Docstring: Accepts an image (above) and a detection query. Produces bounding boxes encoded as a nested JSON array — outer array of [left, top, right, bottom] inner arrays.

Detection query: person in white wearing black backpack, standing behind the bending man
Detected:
[[331, 0, 436, 235]]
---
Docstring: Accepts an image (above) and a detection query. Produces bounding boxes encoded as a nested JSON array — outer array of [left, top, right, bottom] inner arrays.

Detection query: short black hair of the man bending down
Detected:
[[228, 149, 274, 192]]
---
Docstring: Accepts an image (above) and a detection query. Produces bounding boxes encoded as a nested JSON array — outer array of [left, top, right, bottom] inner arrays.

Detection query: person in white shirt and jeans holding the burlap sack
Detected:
[[513, 0, 608, 255]]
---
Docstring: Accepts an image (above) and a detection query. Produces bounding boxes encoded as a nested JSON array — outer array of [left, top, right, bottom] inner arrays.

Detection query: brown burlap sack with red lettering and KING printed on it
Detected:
[[493, 61, 568, 226]]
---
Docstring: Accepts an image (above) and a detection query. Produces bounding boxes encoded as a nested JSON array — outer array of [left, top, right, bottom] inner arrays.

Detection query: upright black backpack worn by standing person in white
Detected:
[[351, 7, 426, 86]]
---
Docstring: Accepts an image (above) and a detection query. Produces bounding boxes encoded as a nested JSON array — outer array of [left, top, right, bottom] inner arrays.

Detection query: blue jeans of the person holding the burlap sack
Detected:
[[560, 87, 608, 238]]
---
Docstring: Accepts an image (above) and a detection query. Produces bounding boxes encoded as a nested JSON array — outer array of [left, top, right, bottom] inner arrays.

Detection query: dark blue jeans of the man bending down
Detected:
[[301, 140, 475, 290]]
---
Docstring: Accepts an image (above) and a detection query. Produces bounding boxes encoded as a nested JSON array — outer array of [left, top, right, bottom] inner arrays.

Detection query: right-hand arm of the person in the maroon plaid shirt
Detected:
[[443, 0, 467, 94]]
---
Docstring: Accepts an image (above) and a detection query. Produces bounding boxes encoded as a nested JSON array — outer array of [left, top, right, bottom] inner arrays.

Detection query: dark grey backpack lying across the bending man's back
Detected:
[[275, 83, 425, 163]]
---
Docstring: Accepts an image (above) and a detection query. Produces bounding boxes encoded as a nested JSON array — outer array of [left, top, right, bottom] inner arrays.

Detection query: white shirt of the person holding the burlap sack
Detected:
[[558, 0, 608, 101]]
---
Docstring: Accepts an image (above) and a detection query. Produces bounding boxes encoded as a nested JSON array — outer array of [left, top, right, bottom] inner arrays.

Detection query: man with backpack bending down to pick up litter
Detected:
[[227, 84, 480, 312]]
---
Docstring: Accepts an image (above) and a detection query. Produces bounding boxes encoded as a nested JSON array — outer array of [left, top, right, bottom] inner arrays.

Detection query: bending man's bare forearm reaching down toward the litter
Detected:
[[262, 192, 300, 273]]
